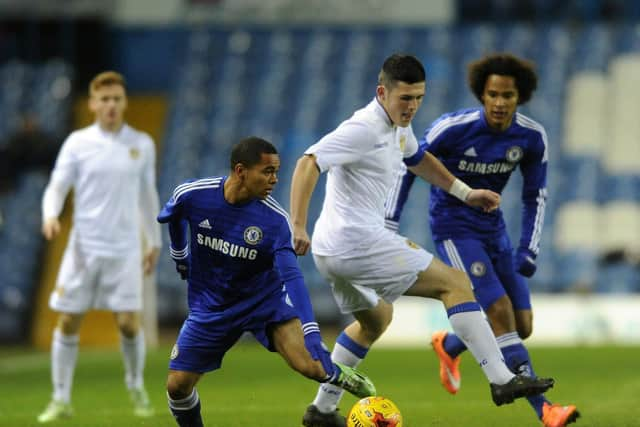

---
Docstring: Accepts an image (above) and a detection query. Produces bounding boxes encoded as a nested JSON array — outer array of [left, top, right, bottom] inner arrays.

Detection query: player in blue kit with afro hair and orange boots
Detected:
[[386, 54, 579, 427]]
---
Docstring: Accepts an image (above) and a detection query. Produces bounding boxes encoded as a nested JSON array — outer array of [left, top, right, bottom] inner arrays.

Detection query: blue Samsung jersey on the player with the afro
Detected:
[[387, 108, 547, 254]]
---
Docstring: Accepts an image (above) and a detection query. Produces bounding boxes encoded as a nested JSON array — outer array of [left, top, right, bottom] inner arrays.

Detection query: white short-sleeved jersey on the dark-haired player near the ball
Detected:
[[305, 99, 418, 256]]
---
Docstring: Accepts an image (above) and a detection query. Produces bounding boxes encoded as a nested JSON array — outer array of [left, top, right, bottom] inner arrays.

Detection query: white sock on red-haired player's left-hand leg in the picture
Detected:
[[51, 328, 80, 403]]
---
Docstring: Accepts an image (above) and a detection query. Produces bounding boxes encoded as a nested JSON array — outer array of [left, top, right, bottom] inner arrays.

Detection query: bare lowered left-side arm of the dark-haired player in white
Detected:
[[290, 155, 320, 255]]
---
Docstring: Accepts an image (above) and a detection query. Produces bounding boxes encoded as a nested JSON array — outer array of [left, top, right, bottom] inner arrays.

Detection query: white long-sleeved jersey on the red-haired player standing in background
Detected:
[[42, 123, 161, 256]]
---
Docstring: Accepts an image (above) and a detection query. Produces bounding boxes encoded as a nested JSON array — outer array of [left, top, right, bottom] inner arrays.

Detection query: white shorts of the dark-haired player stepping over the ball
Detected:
[[313, 229, 433, 313]]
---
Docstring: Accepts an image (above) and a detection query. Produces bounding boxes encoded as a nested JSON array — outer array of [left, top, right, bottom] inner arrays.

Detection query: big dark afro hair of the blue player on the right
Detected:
[[468, 53, 538, 105]]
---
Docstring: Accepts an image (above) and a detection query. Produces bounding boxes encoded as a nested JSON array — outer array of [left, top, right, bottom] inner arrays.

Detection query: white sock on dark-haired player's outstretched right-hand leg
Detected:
[[449, 311, 514, 384]]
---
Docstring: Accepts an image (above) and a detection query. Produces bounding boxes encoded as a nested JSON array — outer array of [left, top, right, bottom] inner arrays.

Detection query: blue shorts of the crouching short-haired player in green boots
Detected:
[[169, 289, 299, 373]]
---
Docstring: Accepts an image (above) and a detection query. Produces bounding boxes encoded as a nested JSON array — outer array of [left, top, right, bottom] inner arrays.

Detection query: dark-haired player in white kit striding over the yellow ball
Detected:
[[291, 54, 553, 427]]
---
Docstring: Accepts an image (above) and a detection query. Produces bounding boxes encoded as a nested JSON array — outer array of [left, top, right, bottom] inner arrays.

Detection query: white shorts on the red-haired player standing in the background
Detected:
[[49, 241, 142, 313]]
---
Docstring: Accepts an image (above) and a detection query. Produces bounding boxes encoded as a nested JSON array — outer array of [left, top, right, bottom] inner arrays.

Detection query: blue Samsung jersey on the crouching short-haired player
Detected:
[[158, 177, 301, 319]]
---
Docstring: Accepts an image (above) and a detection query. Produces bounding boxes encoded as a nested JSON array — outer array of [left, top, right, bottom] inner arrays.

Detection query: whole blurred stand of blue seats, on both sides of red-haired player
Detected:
[[0, 0, 640, 334]]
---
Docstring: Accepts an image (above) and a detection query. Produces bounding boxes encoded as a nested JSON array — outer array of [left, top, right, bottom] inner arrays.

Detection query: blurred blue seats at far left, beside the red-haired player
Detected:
[[0, 59, 73, 342]]
